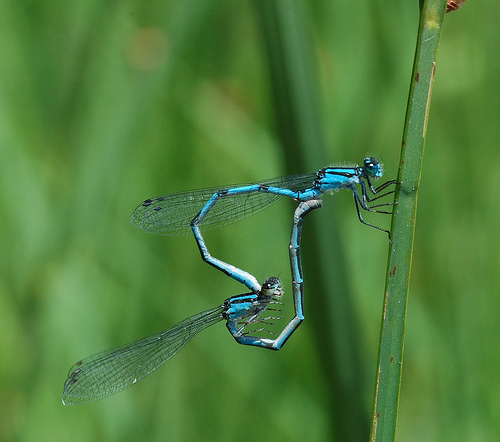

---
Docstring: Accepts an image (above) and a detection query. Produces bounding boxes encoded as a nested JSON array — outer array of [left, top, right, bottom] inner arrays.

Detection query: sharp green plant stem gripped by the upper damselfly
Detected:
[[370, 0, 446, 441]]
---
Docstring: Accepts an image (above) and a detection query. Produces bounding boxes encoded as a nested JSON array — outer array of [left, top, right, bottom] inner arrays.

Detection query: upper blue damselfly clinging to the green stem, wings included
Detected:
[[130, 157, 396, 292]]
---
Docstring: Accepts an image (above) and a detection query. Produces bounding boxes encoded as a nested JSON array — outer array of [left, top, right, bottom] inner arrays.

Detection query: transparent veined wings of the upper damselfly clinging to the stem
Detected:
[[130, 173, 316, 235]]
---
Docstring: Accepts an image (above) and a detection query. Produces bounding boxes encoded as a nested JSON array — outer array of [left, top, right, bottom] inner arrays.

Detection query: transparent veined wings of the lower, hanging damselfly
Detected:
[[63, 306, 223, 405]]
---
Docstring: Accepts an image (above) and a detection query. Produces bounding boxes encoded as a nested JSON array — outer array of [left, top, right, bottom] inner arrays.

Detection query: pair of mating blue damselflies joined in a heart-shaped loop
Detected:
[[63, 157, 396, 404]]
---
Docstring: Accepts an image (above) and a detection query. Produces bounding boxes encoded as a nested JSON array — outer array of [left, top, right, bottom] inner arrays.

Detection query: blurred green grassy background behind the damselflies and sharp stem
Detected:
[[0, 0, 500, 441]]
